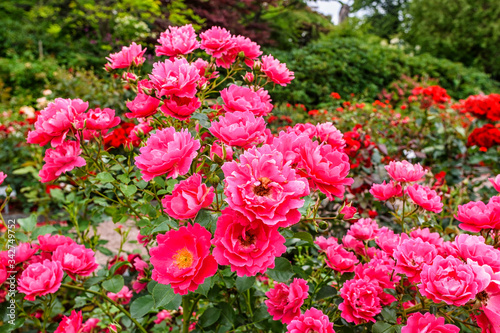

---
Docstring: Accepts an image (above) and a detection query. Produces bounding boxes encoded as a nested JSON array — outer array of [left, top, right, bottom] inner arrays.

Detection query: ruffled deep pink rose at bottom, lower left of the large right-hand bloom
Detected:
[[339, 279, 382, 325]]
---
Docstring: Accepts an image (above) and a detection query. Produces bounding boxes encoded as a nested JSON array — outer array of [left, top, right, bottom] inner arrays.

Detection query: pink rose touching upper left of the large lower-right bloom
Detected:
[[394, 238, 438, 283]]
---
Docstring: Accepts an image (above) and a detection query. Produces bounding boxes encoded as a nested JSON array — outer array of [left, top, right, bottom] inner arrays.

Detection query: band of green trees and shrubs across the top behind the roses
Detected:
[[0, 0, 500, 109]]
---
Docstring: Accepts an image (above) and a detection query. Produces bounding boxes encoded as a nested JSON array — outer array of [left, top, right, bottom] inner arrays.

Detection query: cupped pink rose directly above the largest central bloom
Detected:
[[210, 111, 266, 148]]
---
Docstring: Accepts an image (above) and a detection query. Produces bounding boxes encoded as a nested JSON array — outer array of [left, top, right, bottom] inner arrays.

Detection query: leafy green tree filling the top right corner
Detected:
[[405, 0, 500, 79]]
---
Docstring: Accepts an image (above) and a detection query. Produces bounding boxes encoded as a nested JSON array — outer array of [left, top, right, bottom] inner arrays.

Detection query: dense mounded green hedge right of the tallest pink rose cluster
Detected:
[[272, 36, 500, 106]]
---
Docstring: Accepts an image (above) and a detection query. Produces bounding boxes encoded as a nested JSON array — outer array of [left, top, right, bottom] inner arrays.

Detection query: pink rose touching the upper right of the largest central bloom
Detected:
[[300, 141, 354, 200]]
